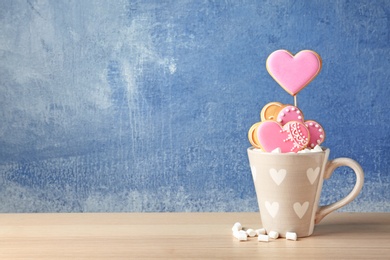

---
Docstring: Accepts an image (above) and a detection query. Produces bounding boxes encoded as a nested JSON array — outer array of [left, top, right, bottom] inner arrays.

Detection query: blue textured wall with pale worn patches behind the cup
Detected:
[[0, 0, 390, 212]]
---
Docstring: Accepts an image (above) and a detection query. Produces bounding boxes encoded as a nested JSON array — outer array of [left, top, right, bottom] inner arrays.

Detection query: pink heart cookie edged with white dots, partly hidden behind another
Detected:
[[276, 105, 325, 148]]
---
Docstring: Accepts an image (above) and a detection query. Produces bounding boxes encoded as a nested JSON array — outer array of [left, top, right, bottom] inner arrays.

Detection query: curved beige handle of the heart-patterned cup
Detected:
[[315, 158, 364, 224]]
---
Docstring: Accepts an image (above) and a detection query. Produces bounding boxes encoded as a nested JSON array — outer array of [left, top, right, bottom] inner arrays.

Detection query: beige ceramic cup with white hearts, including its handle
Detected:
[[248, 147, 364, 237]]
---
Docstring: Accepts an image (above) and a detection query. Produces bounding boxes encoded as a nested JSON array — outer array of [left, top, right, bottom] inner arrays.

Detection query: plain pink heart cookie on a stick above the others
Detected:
[[266, 50, 322, 96]]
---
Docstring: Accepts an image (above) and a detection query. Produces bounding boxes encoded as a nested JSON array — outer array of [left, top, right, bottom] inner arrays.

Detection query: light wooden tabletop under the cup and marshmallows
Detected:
[[0, 213, 390, 259]]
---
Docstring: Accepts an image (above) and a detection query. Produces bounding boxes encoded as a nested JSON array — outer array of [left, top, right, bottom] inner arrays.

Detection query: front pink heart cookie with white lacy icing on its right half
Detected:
[[255, 120, 309, 153]]
